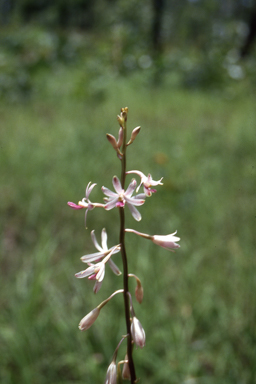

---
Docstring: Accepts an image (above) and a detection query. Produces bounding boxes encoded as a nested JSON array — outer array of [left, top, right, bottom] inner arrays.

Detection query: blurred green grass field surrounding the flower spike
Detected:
[[0, 74, 256, 384]]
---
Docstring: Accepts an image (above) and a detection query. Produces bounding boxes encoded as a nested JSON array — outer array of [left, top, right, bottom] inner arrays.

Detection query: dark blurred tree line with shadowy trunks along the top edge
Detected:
[[0, 0, 256, 57]]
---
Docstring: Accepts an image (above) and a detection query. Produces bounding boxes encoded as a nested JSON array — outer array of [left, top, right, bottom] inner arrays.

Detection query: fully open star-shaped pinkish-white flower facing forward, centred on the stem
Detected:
[[101, 176, 146, 221]]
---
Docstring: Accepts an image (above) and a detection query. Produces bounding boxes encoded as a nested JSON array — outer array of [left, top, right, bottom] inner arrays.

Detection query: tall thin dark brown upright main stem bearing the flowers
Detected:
[[119, 111, 136, 384]]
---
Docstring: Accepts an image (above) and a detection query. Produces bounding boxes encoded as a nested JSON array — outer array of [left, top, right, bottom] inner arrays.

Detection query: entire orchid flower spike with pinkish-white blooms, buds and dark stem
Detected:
[[68, 108, 180, 384]]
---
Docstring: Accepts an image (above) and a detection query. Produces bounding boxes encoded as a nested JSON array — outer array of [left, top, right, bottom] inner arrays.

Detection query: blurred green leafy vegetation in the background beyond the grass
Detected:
[[0, 0, 256, 101]]
